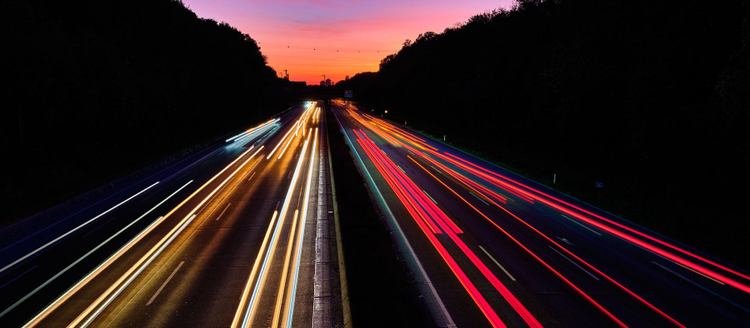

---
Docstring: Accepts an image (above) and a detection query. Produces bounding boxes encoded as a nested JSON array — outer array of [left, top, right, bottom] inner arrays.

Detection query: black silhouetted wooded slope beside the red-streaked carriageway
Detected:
[[337, 0, 750, 266]]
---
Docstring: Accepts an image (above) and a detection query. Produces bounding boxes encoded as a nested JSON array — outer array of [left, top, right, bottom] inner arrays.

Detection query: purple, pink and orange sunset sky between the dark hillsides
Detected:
[[183, 0, 512, 84]]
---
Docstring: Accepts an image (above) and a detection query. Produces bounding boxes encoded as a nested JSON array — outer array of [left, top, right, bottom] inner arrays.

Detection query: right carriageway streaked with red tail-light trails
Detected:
[[329, 100, 750, 327]]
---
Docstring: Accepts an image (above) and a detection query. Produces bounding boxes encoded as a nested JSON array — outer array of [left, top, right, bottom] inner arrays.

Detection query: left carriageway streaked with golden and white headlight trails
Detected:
[[0, 102, 341, 327]]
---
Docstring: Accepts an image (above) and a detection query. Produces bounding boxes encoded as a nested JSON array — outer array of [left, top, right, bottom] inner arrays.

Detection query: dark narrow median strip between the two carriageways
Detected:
[[326, 110, 438, 327]]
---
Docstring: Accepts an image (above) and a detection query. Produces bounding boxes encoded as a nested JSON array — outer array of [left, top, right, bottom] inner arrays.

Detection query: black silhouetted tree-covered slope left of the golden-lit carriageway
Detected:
[[0, 0, 294, 224]]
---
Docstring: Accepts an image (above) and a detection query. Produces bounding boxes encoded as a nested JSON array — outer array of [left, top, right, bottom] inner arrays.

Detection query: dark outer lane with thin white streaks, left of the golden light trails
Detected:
[[0, 115, 279, 326]]
